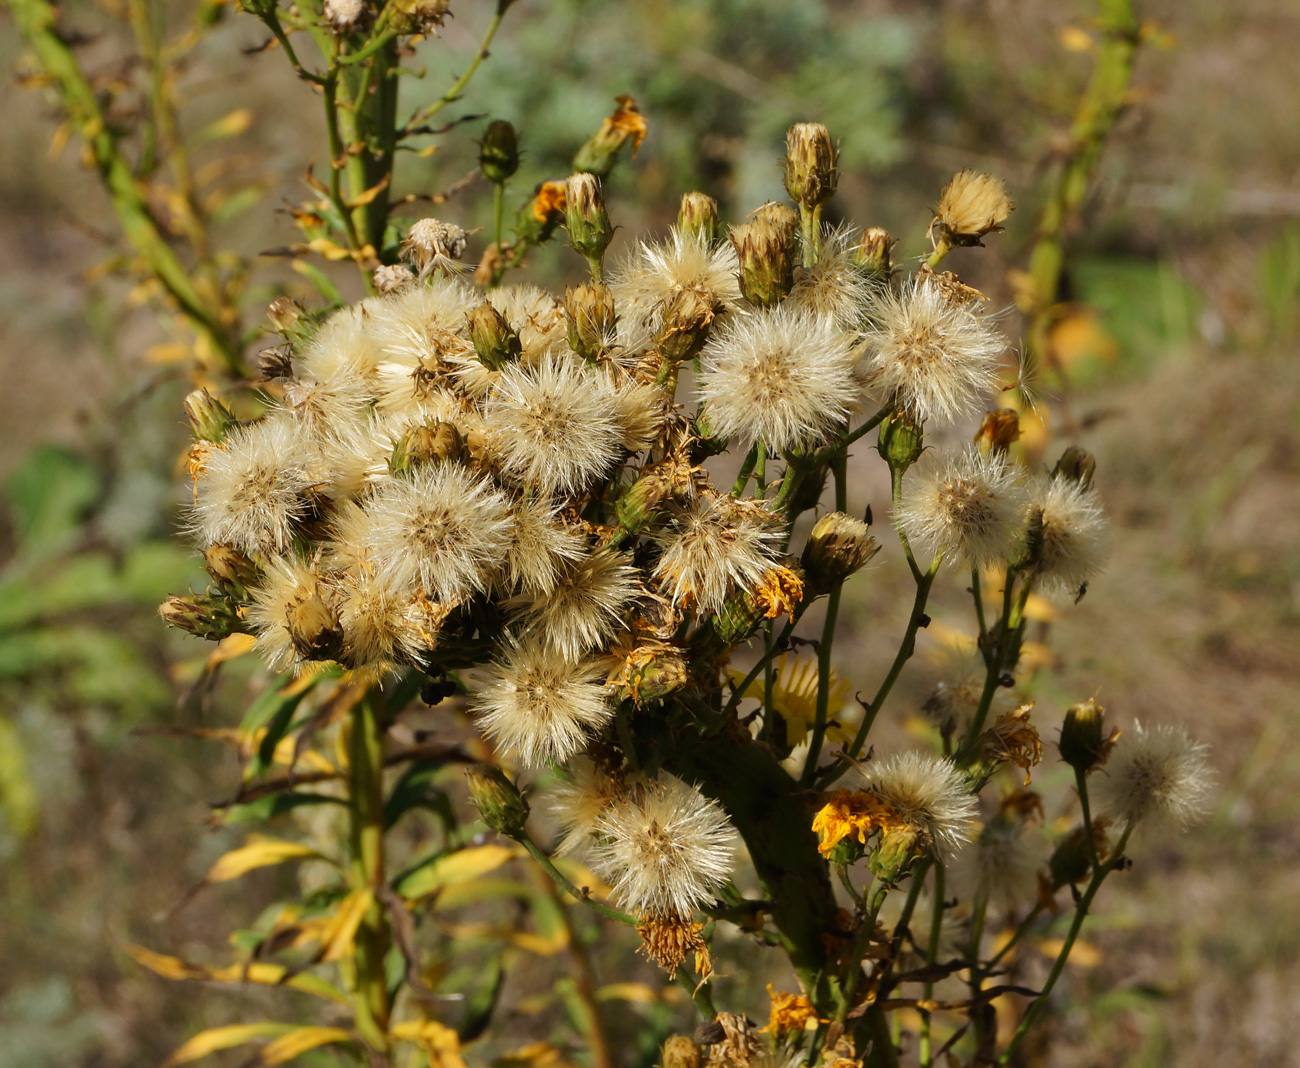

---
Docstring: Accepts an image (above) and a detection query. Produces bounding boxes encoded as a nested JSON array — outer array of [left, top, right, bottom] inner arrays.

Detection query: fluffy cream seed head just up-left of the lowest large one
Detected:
[[473, 641, 614, 767]]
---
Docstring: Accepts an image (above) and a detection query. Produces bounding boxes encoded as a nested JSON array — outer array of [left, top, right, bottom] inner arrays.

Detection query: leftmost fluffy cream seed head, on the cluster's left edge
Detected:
[[192, 417, 319, 555]]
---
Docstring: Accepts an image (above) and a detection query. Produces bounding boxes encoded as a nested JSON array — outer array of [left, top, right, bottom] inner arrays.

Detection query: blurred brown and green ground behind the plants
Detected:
[[0, 0, 1300, 1068]]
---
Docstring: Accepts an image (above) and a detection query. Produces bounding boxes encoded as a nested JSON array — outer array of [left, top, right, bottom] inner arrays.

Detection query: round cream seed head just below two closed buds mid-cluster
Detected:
[[485, 355, 623, 494]]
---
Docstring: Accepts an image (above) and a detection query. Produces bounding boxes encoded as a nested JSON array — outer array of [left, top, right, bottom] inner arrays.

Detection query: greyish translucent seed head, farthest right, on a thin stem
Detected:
[[1089, 724, 1213, 828]]
